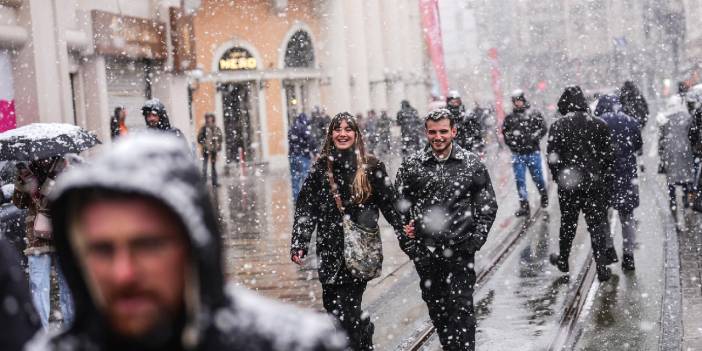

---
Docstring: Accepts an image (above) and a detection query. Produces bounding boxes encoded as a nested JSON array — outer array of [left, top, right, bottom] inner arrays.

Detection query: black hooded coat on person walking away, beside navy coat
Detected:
[[547, 86, 614, 193]]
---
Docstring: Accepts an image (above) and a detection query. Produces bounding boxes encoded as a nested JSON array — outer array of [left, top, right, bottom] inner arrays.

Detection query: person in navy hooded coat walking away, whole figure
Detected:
[[595, 95, 643, 270]]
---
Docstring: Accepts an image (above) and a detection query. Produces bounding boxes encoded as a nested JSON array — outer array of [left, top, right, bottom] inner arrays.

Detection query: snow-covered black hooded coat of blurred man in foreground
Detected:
[[29, 133, 345, 351]]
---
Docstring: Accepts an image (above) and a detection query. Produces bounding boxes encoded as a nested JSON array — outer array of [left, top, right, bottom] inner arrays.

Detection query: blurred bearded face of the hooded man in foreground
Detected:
[[73, 198, 189, 337]]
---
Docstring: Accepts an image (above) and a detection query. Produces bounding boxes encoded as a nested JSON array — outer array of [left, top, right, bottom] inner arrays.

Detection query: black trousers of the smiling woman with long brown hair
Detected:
[[322, 282, 375, 351]]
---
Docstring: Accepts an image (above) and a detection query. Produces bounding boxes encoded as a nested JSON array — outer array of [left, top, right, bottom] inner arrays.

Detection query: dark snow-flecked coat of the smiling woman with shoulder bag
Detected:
[[291, 152, 408, 284]]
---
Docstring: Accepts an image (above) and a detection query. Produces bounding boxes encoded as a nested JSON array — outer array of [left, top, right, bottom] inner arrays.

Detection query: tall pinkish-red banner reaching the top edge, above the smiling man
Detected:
[[419, 0, 448, 96]]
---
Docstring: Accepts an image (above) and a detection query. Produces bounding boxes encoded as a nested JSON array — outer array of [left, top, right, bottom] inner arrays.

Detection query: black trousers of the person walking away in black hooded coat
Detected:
[[558, 187, 609, 264]]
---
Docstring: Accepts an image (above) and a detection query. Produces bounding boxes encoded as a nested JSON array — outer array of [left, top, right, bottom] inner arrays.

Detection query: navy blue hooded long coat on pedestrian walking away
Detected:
[[595, 95, 643, 212]]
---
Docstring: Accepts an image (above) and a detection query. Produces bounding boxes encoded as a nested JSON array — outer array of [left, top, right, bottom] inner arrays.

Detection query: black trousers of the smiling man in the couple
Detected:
[[414, 247, 475, 351]]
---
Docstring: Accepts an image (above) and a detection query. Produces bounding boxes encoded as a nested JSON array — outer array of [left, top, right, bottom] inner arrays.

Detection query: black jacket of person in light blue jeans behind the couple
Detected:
[[502, 109, 547, 155]]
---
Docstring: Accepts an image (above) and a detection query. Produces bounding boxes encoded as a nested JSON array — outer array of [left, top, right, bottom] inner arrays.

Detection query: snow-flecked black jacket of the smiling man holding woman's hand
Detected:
[[396, 143, 497, 253]]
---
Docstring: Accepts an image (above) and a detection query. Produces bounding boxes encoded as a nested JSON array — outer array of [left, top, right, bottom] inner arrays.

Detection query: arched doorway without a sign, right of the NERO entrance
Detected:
[[283, 30, 315, 125]]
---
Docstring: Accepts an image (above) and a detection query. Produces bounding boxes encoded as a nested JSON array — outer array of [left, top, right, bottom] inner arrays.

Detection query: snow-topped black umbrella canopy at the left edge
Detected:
[[0, 123, 100, 161]]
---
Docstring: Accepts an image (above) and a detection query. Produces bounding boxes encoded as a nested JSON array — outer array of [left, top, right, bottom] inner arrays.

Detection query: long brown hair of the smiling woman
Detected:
[[320, 112, 373, 204]]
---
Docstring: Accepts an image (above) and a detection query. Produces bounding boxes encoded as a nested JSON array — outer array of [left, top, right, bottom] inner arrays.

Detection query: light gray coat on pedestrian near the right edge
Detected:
[[658, 98, 694, 184]]
